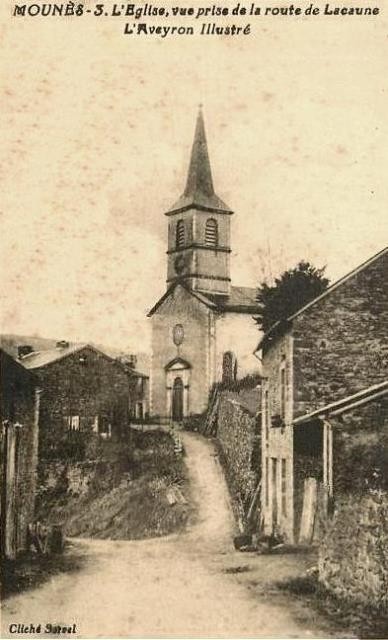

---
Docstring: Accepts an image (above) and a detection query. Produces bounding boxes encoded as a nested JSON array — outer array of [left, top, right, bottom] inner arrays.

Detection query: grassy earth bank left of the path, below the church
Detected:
[[38, 429, 192, 540]]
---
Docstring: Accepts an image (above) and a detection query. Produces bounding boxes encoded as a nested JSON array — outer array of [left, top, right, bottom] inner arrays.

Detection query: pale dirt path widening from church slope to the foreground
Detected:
[[1, 433, 330, 638]]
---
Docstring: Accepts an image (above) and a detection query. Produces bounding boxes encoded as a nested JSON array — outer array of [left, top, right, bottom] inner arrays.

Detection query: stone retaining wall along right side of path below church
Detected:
[[217, 391, 261, 511]]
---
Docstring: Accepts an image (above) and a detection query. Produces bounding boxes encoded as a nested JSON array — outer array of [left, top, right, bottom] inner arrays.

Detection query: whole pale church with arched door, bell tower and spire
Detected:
[[148, 110, 258, 422]]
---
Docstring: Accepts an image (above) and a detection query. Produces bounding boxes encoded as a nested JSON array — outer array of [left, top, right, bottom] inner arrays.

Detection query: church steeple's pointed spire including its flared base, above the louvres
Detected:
[[166, 109, 233, 215]]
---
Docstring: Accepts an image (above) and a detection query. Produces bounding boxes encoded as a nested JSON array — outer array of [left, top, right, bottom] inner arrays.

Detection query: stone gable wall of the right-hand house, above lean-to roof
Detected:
[[292, 252, 388, 415]]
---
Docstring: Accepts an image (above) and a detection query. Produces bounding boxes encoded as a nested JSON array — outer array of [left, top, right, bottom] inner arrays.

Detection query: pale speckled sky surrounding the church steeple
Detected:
[[0, 1, 388, 352]]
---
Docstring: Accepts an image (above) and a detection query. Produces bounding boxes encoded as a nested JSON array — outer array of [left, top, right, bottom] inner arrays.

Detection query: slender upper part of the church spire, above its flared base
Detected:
[[184, 105, 214, 198]]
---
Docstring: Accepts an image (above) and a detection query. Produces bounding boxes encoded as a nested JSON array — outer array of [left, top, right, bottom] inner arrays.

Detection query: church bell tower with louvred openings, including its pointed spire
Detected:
[[166, 108, 233, 295]]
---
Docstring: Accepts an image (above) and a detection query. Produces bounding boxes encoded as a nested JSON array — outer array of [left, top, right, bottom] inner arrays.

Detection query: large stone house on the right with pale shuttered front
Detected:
[[257, 248, 388, 540]]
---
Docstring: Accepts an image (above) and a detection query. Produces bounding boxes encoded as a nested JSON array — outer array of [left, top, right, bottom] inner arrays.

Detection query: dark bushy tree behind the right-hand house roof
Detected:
[[255, 260, 329, 332]]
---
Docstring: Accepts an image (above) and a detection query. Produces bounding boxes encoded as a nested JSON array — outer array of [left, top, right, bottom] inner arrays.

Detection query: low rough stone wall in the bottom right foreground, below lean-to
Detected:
[[319, 491, 388, 608]]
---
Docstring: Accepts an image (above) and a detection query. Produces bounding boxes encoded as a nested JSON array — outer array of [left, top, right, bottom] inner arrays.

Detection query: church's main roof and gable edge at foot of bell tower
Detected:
[[147, 282, 259, 317]]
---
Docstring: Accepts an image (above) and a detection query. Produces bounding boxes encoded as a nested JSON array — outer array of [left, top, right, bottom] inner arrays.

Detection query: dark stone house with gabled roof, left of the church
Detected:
[[20, 341, 129, 458]]
